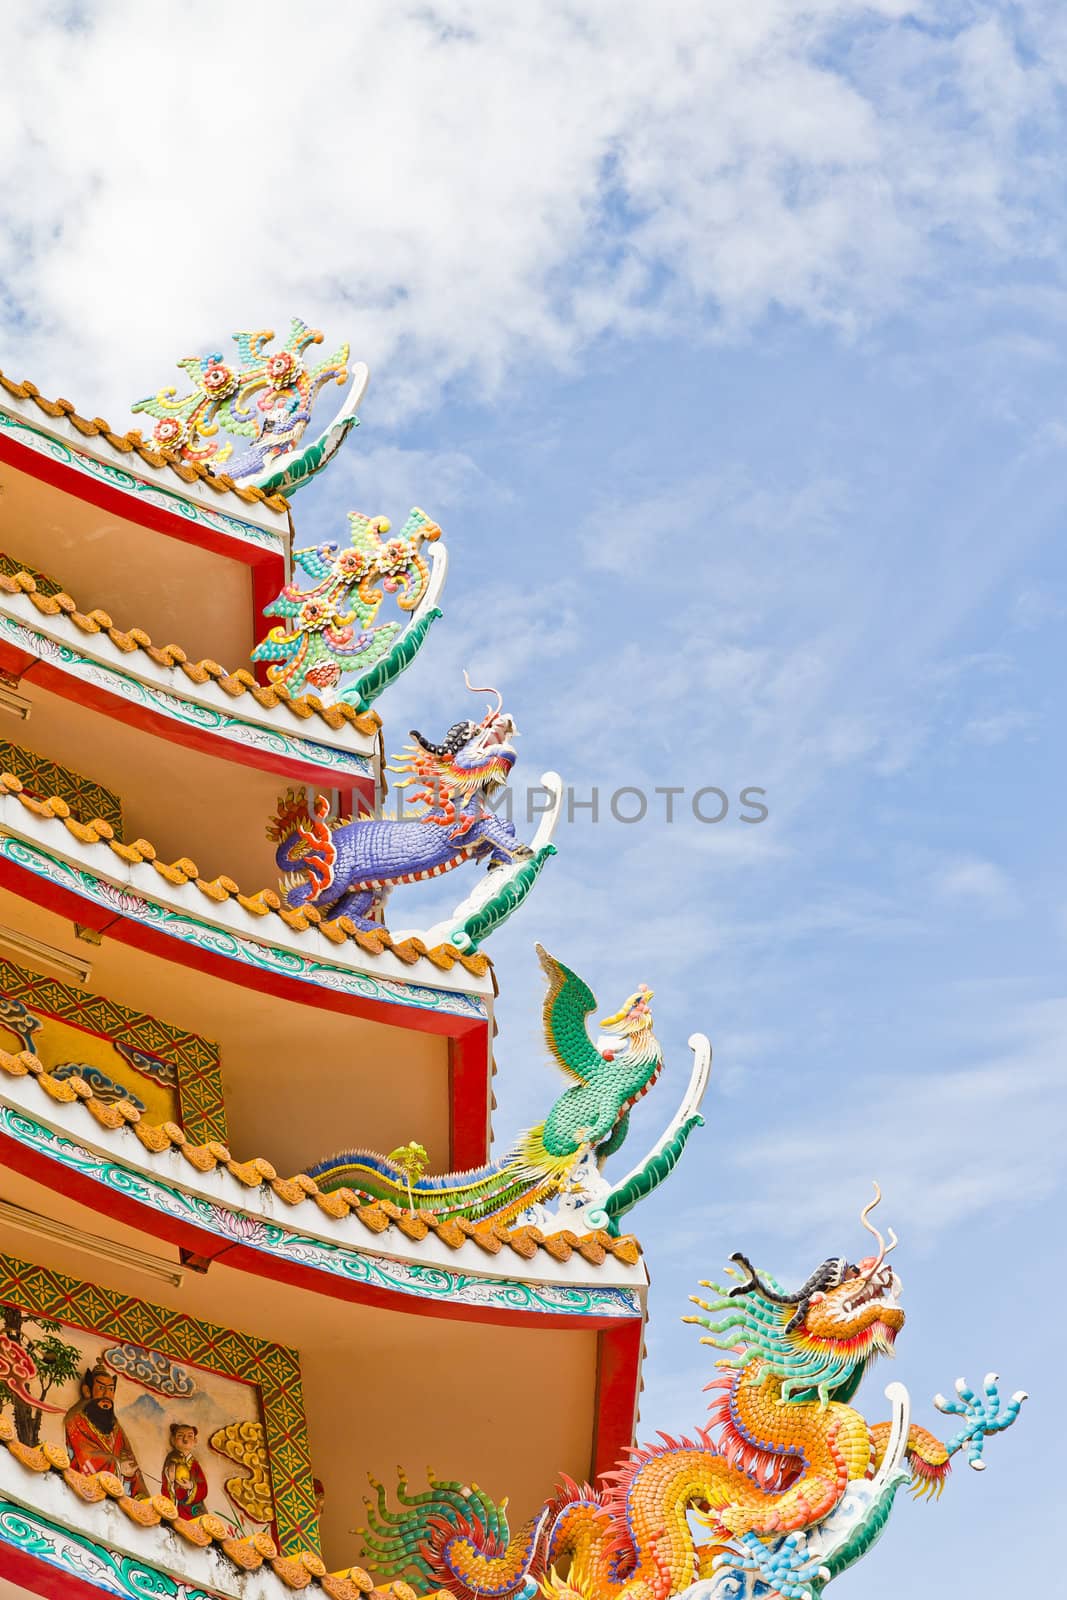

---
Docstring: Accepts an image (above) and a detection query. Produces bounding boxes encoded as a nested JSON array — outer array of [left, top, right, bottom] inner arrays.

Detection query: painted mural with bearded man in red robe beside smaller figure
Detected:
[[0, 1302, 274, 1534]]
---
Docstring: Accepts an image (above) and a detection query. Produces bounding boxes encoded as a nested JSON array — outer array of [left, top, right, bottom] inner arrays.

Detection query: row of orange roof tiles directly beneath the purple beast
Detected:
[[0, 773, 490, 978]]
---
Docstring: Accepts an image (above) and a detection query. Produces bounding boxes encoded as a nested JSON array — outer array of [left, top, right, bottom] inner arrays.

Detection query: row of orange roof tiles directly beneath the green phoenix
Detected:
[[0, 1050, 641, 1267]]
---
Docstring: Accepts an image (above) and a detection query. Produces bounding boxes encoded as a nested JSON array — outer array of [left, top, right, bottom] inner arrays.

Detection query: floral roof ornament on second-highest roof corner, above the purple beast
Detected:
[[251, 506, 445, 710]]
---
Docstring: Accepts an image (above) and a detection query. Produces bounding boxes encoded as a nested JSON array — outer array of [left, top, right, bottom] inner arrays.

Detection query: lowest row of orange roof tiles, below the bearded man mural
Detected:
[[0, 1416, 435, 1600]]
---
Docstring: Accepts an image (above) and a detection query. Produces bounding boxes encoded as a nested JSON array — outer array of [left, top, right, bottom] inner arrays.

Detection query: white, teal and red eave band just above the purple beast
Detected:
[[0, 590, 378, 803]]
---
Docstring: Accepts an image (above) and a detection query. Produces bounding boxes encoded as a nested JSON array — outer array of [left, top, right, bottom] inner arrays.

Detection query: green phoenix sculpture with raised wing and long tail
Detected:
[[309, 946, 702, 1227]]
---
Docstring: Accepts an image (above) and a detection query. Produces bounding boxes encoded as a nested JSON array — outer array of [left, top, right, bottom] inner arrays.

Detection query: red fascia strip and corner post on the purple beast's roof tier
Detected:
[[0, 859, 491, 1171]]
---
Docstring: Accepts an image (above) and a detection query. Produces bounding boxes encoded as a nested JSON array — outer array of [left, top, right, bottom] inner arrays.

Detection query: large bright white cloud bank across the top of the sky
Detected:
[[0, 0, 1056, 421]]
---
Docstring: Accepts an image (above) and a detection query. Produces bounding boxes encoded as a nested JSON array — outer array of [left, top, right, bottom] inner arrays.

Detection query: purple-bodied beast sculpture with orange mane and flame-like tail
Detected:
[[267, 680, 533, 931]]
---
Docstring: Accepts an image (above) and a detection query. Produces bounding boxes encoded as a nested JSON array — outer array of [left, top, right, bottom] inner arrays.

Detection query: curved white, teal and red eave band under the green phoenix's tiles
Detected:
[[0, 1077, 648, 1330]]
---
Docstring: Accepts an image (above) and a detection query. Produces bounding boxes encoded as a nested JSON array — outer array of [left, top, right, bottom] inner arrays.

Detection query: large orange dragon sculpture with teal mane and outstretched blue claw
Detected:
[[363, 1186, 1025, 1600]]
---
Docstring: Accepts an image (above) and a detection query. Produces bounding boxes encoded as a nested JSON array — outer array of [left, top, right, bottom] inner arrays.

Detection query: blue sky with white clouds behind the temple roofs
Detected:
[[0, 0, 1067, 1600]]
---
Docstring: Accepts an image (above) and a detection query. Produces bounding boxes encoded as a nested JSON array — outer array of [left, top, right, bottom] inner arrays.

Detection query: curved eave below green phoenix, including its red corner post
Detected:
[[0, 1078, 648, 1472]]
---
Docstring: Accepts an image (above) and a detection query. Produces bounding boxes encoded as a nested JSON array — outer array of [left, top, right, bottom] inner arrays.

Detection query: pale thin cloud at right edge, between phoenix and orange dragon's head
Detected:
[[661, 997, 1067, 1258]]
